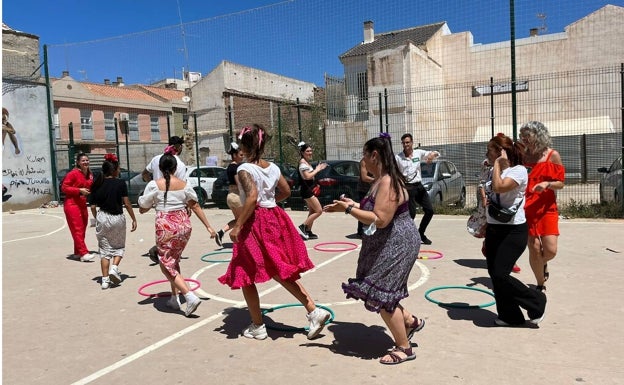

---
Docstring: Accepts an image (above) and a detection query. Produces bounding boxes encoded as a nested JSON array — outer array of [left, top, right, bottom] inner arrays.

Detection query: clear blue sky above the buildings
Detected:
[[2, 0, 624, 86]]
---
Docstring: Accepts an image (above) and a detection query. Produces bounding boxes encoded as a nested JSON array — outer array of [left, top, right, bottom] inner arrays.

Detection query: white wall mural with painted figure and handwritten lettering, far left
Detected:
[[2, 81, 54, 211]]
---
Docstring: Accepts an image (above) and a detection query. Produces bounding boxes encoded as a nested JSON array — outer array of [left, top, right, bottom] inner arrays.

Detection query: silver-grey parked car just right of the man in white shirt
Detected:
[[420, 159, 466, 207]]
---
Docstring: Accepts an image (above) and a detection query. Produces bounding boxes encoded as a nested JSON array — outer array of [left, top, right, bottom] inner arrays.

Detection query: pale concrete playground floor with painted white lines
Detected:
[[2, 207, 624, 385]]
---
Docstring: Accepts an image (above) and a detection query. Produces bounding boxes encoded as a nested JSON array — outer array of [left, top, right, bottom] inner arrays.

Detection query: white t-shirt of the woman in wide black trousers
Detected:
[[485, 165, 529, 225]]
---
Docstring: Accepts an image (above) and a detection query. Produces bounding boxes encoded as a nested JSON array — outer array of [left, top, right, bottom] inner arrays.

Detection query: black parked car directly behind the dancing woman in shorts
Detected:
[[288, 160, 360, 210]]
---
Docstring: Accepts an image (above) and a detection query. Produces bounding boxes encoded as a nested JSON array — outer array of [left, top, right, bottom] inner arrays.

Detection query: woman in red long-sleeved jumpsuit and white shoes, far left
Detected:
[[61, 153, 95, 262]]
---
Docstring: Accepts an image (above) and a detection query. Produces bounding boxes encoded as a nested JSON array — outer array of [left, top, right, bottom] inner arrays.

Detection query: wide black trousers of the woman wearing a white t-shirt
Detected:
[[485, 223, 546, 325]]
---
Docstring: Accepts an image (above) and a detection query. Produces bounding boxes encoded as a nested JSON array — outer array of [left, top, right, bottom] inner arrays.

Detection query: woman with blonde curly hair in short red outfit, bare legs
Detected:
[[520, 121, 565, 291]]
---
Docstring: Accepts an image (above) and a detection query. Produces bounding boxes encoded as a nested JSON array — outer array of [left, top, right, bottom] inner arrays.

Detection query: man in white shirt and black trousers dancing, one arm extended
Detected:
[[395, 133, 440, 245]]
